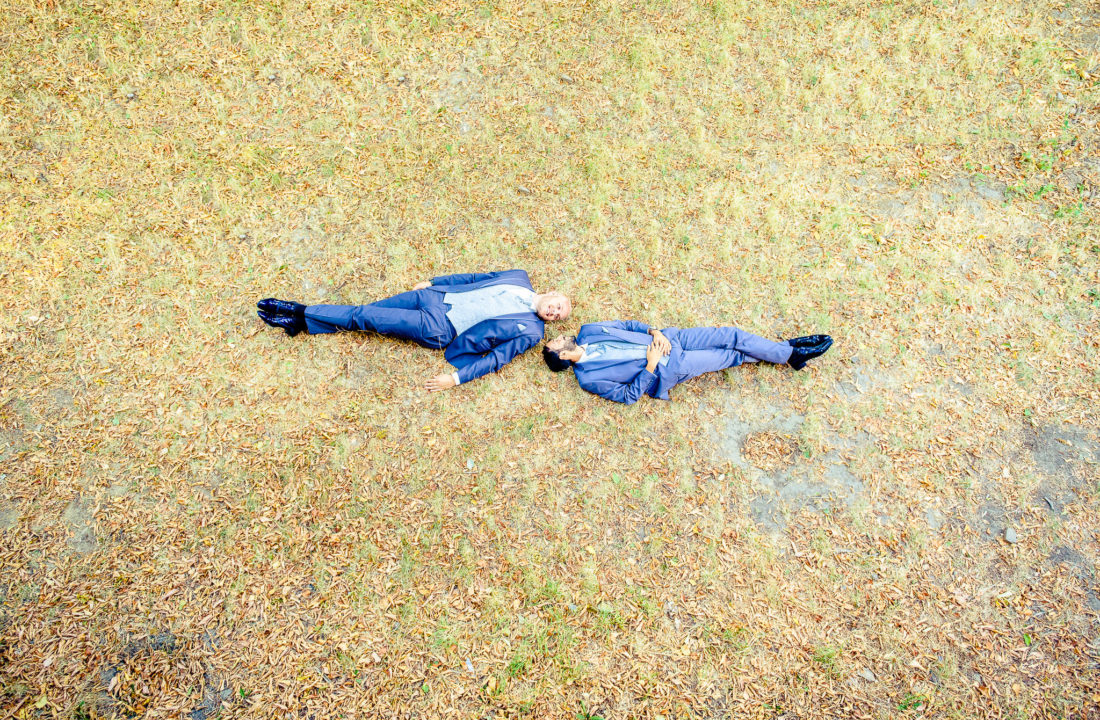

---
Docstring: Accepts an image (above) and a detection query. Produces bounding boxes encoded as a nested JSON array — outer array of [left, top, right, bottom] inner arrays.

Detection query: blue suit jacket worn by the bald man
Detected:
[[430, 270, 546, 383]]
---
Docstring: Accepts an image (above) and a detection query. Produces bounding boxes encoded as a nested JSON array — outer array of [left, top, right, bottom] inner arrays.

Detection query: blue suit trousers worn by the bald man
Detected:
[[305, 288, 454, 350]]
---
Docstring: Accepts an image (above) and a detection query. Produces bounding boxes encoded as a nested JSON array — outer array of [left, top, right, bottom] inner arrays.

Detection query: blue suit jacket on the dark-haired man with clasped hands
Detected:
[[573, 320, 682, 405]]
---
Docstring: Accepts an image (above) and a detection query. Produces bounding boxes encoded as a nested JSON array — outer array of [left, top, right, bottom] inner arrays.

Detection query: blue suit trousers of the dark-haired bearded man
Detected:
[[668, 328, 792, 385]]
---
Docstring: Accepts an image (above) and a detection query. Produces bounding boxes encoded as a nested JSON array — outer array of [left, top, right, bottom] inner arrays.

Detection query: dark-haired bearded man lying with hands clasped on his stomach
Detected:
[[542, 320, 833, 405]]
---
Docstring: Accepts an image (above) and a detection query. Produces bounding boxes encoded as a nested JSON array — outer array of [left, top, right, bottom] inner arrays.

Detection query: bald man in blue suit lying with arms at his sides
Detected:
[[256, 270, 572, 390]]
